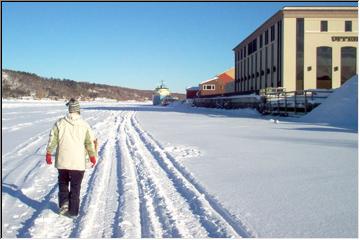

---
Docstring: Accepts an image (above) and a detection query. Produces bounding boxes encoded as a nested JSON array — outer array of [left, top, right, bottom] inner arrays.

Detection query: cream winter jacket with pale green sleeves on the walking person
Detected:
[[46, 113, 96, 171]]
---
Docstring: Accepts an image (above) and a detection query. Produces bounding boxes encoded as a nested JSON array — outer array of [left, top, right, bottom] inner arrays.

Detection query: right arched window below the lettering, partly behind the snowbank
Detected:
[[341, 47, 356, 85]]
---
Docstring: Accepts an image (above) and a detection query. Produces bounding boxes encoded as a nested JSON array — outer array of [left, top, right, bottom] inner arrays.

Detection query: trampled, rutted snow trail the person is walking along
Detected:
[[2, 110, 256, 238]]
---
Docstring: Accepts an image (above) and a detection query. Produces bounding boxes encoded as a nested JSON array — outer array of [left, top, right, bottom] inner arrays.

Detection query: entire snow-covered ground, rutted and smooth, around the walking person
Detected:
[[2, 79, 358, 238]]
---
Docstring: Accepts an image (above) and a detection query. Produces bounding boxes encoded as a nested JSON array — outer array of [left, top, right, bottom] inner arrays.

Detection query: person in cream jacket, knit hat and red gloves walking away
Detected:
[[46, 98, 96, 217]]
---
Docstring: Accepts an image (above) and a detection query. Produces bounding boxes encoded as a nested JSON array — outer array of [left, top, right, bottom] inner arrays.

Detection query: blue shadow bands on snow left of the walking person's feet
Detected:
[[2, 183, 58, 237]]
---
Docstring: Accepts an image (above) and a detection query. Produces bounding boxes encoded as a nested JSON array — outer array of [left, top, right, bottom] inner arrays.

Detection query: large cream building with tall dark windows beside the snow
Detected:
[[233, 7, 358, 93]]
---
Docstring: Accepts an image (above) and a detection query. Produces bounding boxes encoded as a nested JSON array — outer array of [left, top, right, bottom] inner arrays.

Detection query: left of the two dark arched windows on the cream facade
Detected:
[[316, 47, 332, 89]]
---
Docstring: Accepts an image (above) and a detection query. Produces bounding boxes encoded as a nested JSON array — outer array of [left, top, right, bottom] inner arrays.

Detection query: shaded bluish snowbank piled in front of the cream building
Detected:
[[302, 75, 358, 129]]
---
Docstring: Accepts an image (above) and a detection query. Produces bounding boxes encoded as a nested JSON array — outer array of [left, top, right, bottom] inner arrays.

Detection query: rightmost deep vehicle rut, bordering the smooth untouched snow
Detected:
[[131, 114, 256, 237]]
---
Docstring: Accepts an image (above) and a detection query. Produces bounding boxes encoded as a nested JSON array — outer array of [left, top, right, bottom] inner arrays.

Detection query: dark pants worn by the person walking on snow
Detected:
[[58, 169, 85, 215]]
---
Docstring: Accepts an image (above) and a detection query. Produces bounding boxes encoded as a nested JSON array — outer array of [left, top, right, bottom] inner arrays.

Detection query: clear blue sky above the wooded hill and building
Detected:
[[2, 2, 357, 92]]
